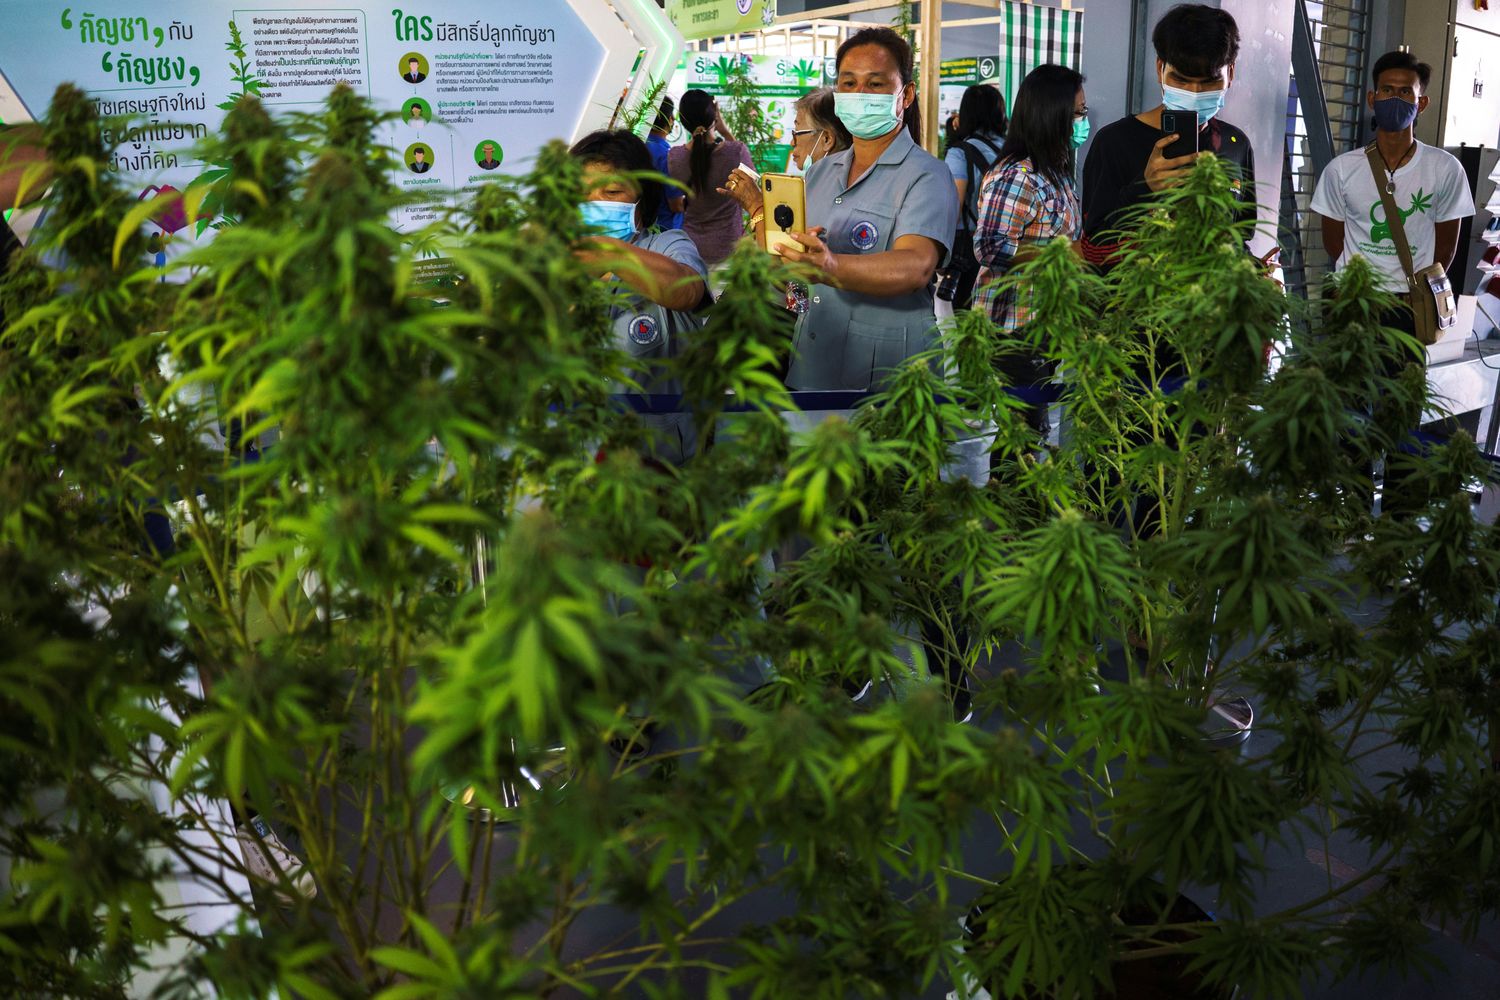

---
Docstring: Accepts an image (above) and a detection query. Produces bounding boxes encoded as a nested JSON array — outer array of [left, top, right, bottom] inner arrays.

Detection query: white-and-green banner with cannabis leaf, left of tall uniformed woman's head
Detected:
[[668, 52, 836, 169]]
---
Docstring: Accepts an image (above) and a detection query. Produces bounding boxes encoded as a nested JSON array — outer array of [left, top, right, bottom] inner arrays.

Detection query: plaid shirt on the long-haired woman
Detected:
[[974, 159, 1083, 333]]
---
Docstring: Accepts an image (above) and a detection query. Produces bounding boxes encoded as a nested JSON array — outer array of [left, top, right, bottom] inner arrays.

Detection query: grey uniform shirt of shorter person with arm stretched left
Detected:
[[609, 229, 708, 463]]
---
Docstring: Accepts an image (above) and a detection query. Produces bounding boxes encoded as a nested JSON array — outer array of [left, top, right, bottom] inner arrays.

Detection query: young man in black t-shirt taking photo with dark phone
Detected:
[[1082, 3, 1254, 270]]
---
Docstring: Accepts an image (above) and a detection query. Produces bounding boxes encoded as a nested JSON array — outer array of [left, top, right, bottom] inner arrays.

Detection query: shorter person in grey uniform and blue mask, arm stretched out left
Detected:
[[570, 130, 711, 462]]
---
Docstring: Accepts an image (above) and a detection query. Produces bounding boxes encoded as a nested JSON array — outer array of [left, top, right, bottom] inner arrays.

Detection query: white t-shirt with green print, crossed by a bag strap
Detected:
[[1311, 142, 1475, 292]]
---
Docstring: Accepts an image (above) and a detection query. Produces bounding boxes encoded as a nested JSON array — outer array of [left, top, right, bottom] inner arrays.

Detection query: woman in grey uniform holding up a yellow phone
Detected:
[[785, 28, 959, 390]]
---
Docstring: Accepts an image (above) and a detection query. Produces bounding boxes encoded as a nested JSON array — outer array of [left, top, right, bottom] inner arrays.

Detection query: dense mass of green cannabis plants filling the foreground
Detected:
[[0, 88, 1500, 1000]]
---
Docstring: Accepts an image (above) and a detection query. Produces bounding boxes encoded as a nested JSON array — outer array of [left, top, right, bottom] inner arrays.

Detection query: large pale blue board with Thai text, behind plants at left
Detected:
[[0, 0, 615, 239]]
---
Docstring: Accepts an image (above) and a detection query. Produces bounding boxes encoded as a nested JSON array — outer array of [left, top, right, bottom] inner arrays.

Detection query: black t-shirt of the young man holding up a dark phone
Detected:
[[1083, 115, 1256, 268]]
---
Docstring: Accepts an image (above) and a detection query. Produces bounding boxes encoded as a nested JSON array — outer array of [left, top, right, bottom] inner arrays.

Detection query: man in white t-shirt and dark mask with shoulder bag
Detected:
[[1313, 52, 1475, 322]]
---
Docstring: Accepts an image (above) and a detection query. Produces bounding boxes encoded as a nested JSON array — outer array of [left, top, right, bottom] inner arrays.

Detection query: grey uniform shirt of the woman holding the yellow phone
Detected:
[[786, 127, 959, 390]]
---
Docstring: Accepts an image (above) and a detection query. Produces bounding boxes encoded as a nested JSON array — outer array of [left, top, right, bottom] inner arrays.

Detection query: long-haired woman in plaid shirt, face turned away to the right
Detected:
[[974, 64, 1089, 435]]
